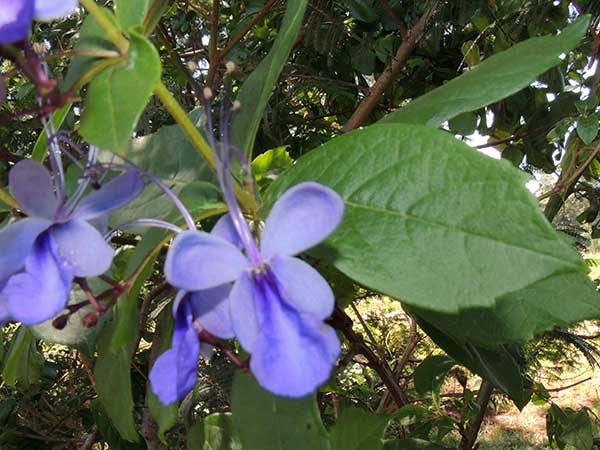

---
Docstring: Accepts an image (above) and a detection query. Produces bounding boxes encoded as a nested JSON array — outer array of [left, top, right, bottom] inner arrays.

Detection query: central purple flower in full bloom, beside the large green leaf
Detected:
[[162, 182, 344, 397]]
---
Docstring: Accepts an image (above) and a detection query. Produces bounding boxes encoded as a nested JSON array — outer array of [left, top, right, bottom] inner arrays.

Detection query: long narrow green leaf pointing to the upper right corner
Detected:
[[380, 16, 590, 127]]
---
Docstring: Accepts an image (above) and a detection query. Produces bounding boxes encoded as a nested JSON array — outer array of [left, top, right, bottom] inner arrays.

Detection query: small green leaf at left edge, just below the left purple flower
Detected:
[[2, 325, 44, 389]]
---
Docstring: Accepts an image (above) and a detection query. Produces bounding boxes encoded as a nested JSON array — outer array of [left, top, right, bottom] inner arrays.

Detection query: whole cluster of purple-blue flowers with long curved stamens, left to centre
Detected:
[[0, 87, 344, 404]]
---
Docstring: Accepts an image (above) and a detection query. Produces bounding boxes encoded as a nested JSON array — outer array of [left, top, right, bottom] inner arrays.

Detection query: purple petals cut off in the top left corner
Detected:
[[0, 0, 78, 44]]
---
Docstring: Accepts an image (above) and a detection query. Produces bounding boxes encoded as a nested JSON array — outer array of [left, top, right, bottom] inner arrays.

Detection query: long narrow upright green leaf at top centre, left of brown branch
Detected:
[[231, 0, 308, 160]]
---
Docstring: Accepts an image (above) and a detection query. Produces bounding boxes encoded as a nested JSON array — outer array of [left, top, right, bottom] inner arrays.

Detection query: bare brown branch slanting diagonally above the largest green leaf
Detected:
[[344, 6, 436, 131]]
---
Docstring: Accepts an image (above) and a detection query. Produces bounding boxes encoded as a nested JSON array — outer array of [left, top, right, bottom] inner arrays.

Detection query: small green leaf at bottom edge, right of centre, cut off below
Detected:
[[331, 407, 389, 450]]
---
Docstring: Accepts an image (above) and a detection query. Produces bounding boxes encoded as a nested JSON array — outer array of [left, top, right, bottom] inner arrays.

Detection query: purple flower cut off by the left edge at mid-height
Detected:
[[0, 160, 144, 325]]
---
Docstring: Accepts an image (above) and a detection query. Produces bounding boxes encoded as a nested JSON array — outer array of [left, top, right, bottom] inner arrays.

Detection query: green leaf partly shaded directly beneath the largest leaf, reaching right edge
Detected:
[[410, 272, 600, 347]]
